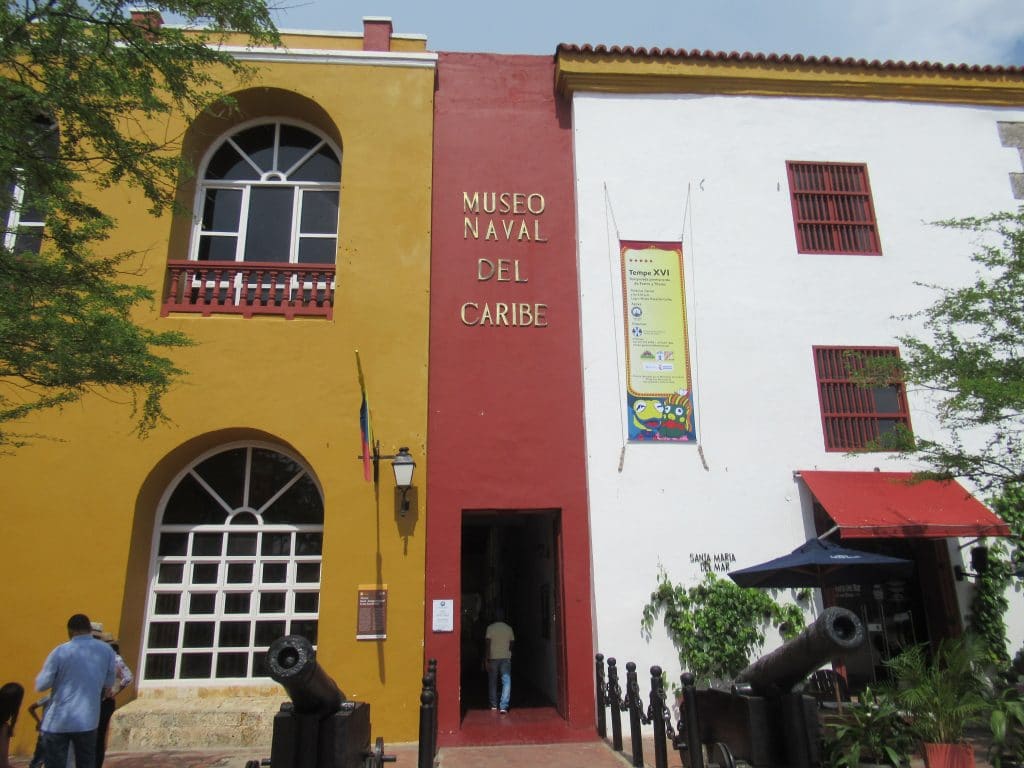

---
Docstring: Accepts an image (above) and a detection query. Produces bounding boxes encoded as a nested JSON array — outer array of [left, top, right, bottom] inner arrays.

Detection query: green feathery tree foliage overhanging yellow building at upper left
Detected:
[[0, 0, 278, 449]]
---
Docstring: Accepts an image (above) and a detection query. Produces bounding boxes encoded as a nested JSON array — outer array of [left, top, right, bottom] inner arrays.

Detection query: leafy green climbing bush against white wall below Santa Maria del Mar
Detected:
[[640, 568, 804, 681]]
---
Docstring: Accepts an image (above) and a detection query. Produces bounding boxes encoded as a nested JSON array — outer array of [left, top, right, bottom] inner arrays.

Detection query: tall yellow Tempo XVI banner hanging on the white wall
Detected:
[[618, 241, 696, 442]]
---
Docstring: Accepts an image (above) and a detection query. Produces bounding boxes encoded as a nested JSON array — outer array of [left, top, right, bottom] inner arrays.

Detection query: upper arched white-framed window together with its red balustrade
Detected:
[[162, 120, 341, 319]]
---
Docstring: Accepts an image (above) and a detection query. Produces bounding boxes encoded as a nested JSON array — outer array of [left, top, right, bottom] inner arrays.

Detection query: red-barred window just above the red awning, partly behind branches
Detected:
[[814, 347, 910, 452]]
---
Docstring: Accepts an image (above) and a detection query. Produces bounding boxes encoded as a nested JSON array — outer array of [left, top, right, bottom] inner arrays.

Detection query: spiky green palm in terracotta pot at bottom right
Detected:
[[886, 638, 989, 768]]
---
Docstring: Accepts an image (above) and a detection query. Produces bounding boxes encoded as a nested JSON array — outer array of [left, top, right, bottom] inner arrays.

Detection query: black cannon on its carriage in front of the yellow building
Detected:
[[246, 635, 395, 768]]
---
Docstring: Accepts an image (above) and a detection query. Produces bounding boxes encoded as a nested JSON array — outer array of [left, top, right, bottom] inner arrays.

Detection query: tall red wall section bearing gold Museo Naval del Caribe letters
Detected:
[[425, 53, 595, 743]]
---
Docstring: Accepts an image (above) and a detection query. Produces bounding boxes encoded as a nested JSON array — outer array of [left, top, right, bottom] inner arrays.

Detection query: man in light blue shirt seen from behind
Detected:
[[36, 613, 115, 768]]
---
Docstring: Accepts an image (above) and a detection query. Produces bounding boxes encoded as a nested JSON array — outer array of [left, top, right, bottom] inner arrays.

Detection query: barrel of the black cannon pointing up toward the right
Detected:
[[736, 607, 865, 695]]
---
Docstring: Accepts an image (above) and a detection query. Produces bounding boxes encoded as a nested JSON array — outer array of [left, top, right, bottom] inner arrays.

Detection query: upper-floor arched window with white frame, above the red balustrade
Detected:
[[190, 121, 341, 264]]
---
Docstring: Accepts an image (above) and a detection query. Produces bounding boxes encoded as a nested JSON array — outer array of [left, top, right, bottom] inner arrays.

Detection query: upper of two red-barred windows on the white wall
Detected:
[[785, 161, 882, 256]]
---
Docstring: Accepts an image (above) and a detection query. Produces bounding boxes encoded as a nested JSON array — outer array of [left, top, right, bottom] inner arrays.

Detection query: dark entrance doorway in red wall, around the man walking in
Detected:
[[460, 510, 564, 716]]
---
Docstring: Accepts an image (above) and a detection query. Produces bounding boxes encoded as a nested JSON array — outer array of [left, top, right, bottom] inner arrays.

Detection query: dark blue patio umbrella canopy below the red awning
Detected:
[[729, 539, 913, 589]]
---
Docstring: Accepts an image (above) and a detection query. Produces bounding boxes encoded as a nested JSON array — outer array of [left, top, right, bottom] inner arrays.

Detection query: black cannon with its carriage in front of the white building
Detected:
[[676, 607, 865, 768]]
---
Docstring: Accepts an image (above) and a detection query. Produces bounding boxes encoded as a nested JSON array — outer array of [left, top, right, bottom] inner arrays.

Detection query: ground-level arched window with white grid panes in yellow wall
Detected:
[[142, 444, 324, 682]]
